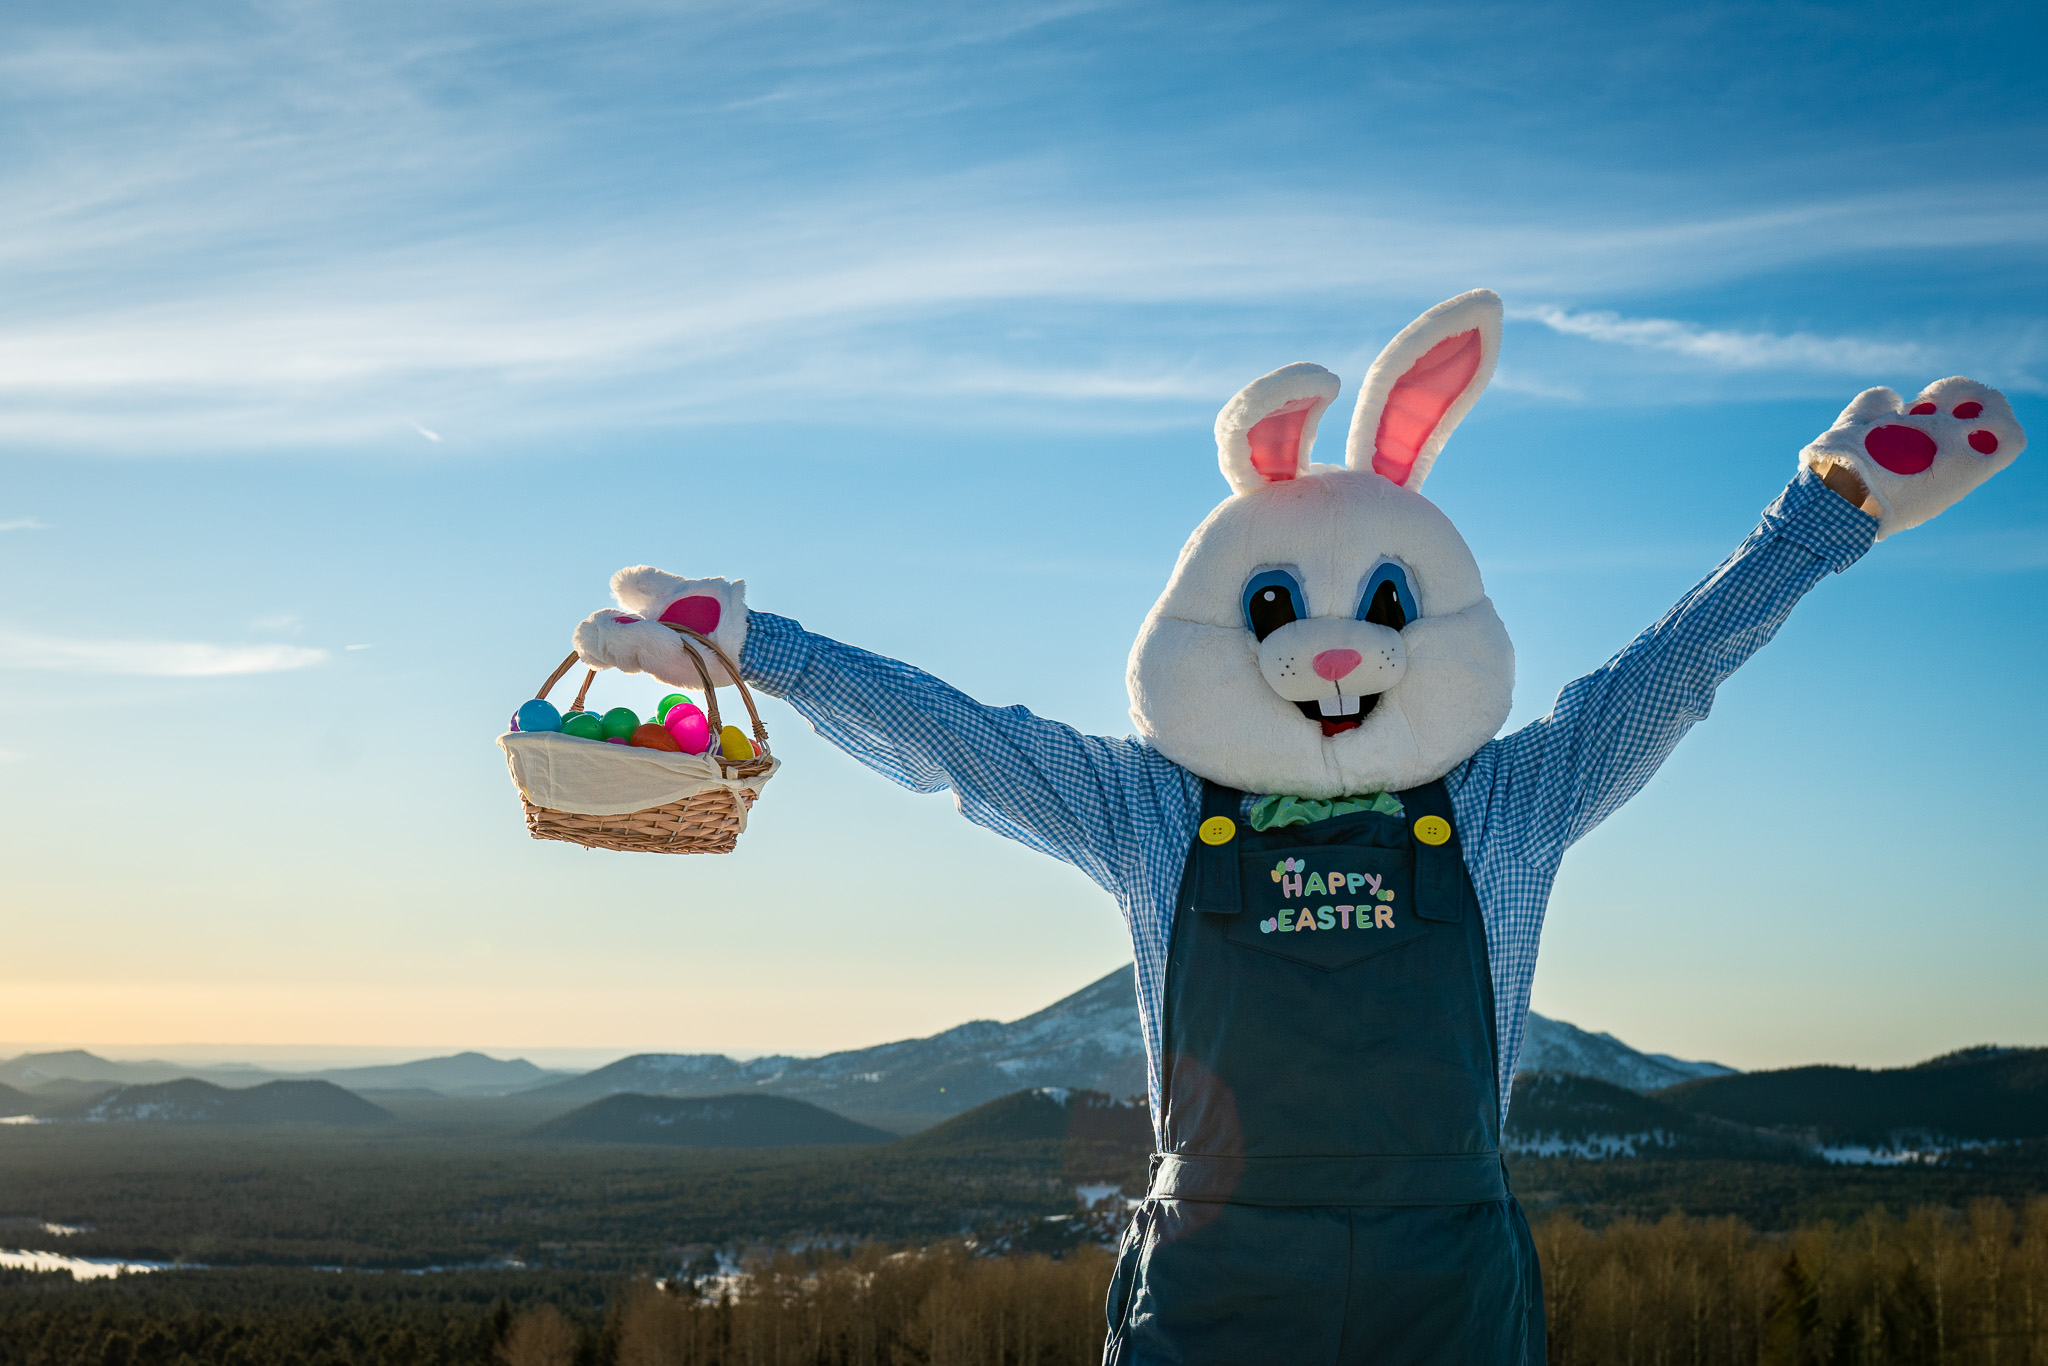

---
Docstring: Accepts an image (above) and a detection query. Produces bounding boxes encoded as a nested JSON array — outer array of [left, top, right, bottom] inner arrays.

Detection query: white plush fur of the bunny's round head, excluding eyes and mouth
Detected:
[[1126, 467, 1516, 797]]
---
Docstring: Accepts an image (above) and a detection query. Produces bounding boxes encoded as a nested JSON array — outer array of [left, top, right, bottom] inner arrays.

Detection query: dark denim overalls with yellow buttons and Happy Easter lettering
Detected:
[[1104, 782, 1544, 1366]]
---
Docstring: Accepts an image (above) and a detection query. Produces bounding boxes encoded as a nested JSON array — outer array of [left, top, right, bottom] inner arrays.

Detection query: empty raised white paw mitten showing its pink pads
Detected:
[[1800, 375, 2028, 541]]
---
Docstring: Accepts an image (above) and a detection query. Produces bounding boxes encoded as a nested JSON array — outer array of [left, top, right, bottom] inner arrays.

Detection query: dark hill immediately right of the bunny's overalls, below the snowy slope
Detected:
[[1501, 1071, 1810, 1159]]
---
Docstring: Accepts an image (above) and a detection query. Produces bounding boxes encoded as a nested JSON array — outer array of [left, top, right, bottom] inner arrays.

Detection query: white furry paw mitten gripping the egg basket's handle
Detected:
[[575, 565, 748, 688]]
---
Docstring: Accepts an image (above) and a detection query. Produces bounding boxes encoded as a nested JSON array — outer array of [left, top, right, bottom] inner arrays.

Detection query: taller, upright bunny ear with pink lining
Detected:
[[1343, 289, 1501, 489]]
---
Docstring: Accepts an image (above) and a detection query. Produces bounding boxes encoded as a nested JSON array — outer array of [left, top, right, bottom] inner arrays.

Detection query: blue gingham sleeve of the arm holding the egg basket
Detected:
[[739, 612, 1186, 895]]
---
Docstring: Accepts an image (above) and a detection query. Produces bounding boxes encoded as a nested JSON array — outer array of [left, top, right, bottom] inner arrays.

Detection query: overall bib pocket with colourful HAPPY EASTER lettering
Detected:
[[1225, 844, 1430, 973]]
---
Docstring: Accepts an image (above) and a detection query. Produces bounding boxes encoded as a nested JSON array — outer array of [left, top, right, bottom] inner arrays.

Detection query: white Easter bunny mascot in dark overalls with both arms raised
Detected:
[[578, 291, 2025, 1366]]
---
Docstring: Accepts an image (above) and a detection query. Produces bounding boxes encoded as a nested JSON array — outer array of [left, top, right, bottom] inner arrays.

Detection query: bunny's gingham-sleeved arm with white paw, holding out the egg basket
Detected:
[[578, 567, 1198, 893]]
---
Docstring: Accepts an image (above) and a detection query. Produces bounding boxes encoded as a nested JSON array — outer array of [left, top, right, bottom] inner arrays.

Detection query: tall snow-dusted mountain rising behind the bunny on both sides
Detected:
[[526, 967, 1731, 1130]]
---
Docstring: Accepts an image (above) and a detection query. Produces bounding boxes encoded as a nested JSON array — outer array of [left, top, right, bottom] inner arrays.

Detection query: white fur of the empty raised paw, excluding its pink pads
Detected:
[[1798, 375, 2028, 541]]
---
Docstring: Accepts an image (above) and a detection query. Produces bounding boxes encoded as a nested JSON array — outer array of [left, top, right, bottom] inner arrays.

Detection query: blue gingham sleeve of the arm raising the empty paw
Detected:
[[1454, 469, 1878, 866]]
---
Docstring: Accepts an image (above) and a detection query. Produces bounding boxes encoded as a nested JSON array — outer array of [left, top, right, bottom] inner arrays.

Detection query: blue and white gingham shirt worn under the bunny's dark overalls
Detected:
[[741, 469, 1878, 1128]]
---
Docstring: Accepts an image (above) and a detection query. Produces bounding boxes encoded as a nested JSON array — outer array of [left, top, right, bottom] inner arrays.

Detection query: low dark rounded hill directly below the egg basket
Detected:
[[530, 1094, 895, 1147]]
